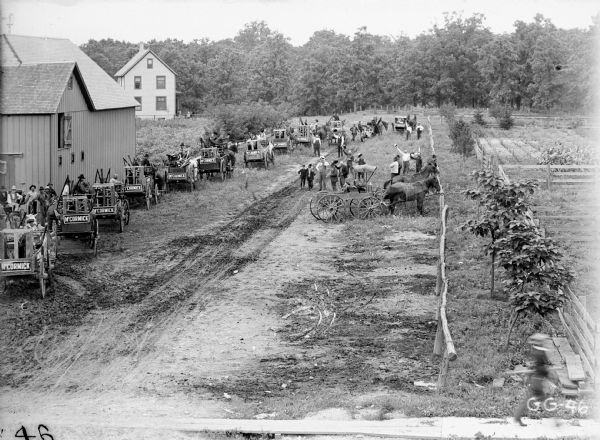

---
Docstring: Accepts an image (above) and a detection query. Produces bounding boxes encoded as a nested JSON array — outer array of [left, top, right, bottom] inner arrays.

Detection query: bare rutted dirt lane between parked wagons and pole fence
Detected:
[[0, 123, 446, 438]]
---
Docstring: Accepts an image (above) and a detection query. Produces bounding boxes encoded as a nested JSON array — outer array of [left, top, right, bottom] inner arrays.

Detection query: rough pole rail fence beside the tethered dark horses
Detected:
[[427, 117, 457, 392]]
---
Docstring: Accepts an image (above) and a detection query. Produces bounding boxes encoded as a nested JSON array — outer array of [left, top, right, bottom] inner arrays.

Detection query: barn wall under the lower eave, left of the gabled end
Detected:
[[0, 115, 50, 189]]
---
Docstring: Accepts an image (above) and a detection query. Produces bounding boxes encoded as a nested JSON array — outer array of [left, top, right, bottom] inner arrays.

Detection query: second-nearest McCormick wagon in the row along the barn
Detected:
[[56, 195, 98, 255]]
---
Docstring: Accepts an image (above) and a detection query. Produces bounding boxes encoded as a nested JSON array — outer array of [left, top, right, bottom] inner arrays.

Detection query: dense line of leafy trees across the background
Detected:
[[81, 13, 600, 115]]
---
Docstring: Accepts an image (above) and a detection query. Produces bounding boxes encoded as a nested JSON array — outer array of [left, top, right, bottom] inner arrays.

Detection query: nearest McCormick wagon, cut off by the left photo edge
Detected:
[[0, 229, 56, 298]]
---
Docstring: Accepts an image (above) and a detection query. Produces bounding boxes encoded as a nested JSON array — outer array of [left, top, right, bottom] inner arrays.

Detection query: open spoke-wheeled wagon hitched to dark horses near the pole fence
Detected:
[[309, 165, 387, 223]]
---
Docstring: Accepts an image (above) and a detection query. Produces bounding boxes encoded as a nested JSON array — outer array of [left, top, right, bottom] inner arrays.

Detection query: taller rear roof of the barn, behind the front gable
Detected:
[[0, 34, 138, 112]]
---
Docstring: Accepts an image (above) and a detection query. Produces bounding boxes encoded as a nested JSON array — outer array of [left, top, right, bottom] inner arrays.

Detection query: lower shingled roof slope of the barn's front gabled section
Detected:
[[0, 63, 85, 114]]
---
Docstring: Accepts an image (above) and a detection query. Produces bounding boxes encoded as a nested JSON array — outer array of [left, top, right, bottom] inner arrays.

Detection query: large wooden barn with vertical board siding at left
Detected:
[[0, 35, 137, 190]]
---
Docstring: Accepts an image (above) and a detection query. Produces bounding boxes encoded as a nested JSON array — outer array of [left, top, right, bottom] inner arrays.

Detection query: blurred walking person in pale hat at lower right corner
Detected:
[[515, 333, 550, 426]]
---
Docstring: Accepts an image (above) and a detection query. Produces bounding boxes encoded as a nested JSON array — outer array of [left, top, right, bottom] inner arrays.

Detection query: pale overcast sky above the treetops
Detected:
[[0, 0, 600, 46]]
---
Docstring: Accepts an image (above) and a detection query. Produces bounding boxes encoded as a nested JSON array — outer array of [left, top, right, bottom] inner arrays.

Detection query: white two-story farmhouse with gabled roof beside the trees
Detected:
[[115, 44, 177, 119]]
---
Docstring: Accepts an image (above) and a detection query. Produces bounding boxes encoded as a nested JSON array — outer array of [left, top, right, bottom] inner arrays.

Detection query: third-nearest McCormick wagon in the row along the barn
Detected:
[[92, 183, 130, 232]]
